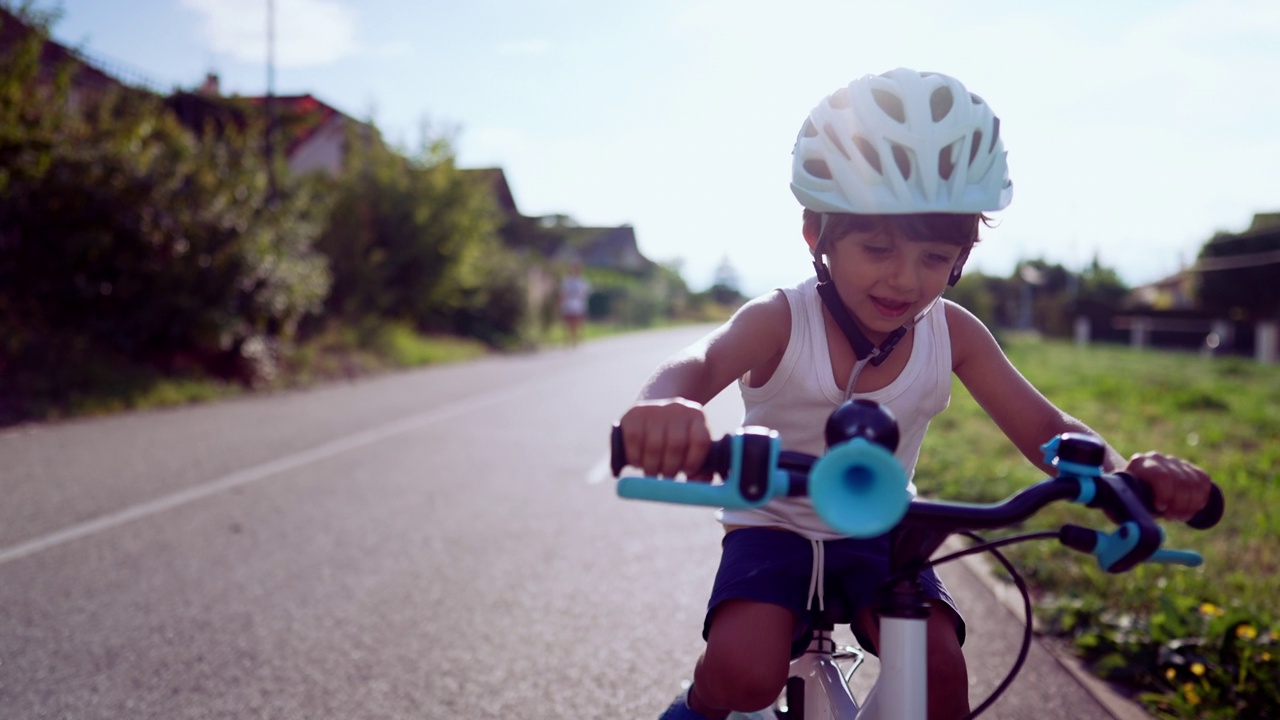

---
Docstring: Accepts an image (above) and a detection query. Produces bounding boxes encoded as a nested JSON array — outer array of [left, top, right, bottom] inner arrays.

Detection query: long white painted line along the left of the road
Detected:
[[0, 388, 519, 565]]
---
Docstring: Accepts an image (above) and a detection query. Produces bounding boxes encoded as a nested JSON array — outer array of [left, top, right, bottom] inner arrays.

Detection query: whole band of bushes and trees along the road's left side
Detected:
[[0, 0, 732, 425]]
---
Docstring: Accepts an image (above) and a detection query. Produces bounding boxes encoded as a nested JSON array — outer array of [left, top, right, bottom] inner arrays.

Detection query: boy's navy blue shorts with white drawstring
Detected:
[[703, 528, 965, 657]]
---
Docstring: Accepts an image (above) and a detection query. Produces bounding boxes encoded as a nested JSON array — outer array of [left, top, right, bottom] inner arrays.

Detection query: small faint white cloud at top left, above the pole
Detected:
[[182, 0, 360, 68]]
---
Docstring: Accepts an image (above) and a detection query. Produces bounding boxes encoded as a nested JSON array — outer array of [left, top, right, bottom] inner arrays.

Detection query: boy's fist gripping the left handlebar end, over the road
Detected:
[[618, 397, 712, 478]]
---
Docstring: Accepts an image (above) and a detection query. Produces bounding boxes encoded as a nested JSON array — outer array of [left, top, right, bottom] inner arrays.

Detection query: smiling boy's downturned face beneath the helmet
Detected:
[[809, 229, 961, 342]]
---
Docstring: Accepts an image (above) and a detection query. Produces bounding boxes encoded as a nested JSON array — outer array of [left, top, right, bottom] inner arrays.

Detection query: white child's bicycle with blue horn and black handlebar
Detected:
[[612, 400, 1224, 720]]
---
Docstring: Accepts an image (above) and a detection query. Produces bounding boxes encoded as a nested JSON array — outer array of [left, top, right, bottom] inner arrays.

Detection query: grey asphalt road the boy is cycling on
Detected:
[[0, 329, 1131, 720]]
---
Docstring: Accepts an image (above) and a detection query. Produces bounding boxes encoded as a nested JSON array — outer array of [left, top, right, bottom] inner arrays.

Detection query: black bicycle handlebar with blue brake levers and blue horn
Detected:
[[612, 401, 1225, 573]]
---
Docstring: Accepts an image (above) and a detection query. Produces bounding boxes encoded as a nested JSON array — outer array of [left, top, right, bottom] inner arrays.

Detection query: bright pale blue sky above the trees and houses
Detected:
[[36, 0, 1280, 295]]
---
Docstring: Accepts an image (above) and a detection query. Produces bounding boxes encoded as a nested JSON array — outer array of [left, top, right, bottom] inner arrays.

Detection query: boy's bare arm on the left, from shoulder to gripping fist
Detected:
[[618, 292, 791, 477]]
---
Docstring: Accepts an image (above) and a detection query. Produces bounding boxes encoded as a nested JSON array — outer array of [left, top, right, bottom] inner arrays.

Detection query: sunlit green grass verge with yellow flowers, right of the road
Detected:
[[916, 338, 1280, 717]]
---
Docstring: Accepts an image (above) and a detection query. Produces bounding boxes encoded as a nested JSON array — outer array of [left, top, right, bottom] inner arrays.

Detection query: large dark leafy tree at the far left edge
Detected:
[[0, 1, 329, 409]]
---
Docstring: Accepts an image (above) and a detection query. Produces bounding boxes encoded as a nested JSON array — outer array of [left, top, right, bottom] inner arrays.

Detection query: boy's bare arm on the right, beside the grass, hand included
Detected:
[[945, 302, 1210, 520]]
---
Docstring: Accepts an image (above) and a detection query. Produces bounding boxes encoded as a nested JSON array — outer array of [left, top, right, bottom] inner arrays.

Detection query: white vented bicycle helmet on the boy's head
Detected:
[[791, 68, 1012, 215]]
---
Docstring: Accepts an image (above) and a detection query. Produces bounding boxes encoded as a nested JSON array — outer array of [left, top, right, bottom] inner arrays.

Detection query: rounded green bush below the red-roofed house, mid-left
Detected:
[[319, 127, 525, 343]]
